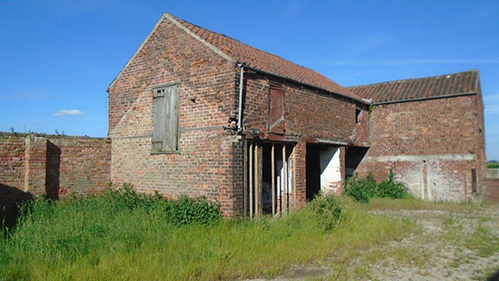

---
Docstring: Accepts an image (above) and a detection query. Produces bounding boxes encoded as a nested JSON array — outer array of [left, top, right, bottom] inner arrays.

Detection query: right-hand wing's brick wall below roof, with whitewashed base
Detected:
[[357, 95, 484, 201]]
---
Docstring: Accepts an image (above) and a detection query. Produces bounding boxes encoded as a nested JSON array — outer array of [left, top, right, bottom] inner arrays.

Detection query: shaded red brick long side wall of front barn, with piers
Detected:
[[244, 72, 368, 206]]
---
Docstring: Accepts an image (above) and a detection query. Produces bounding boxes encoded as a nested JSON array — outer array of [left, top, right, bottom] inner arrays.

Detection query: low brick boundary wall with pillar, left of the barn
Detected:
[[0, 133, 111, 203]]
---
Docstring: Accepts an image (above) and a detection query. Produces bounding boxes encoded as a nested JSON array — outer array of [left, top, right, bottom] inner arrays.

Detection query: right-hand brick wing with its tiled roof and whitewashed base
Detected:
[[348, 70, 486, 201]]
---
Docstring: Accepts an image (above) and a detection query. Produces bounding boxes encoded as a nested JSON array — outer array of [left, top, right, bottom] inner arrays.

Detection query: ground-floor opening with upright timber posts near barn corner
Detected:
[[244, 141, 296, 218]]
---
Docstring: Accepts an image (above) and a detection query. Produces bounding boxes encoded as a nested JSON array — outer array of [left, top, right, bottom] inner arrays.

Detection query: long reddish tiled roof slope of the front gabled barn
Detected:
[[166, 14, 365, 102]]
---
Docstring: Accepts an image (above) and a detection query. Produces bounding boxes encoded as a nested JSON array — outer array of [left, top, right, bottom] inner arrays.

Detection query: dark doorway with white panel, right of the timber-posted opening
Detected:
[[306, 144, 342, 201]]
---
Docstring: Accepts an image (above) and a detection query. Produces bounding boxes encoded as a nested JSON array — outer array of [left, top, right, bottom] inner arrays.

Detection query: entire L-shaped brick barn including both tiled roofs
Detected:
[[108, 14, 485, 216]]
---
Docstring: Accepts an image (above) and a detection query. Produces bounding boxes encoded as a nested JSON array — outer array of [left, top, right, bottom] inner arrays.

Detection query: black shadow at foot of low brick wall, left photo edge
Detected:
[[0, 183, 33, 232]]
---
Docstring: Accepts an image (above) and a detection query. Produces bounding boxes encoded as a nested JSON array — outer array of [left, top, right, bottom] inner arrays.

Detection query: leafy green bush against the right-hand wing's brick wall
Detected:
[[345, 172, 411, 203]]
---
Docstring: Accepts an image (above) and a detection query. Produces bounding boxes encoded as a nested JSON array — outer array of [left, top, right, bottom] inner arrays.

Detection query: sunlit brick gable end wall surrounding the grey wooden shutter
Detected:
[[109, 14, 242, 216]]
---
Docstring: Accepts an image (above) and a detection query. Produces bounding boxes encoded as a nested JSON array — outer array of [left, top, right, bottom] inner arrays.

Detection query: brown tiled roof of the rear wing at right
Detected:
[[347, 70, 479, 103]]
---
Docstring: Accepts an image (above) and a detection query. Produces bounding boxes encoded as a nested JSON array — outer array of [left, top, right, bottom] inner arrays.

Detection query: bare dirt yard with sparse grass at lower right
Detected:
[[252, 202, 499, 280]]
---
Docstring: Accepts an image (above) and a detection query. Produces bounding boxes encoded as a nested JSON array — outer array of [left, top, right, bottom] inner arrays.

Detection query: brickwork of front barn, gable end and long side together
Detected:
[[109, 15, 367, 216]]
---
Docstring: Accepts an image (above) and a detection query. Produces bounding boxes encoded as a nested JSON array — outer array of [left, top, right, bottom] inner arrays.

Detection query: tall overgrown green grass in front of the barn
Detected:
[[0, 187, 416, 280]]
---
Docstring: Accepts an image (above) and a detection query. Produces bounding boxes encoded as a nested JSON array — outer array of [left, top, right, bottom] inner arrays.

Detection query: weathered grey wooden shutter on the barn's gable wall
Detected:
[[152, 85, 179, 152]]
